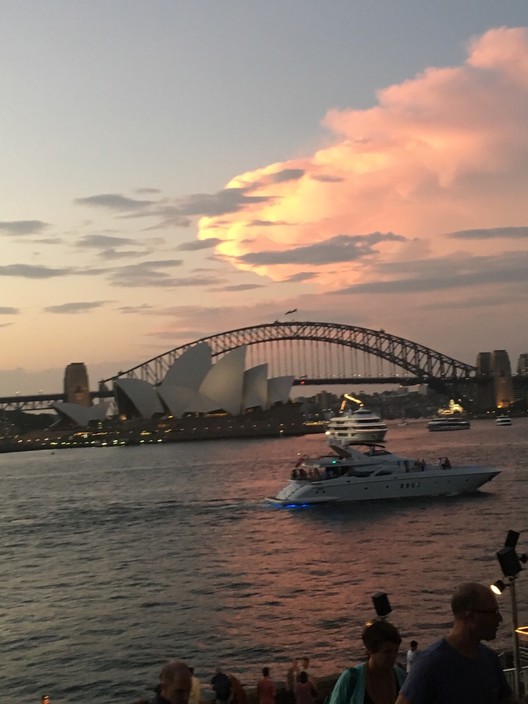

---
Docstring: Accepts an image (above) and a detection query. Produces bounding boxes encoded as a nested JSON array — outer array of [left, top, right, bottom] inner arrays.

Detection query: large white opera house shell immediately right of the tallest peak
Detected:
[[196, 345, 246, 416]]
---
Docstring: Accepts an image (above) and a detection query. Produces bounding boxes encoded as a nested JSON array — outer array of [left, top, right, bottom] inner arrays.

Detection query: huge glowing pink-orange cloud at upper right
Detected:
[[199, 28, 528, 289]]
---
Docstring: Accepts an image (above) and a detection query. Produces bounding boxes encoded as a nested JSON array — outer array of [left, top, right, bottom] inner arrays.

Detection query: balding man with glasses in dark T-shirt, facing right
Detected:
[[396, 582, 514, 704]]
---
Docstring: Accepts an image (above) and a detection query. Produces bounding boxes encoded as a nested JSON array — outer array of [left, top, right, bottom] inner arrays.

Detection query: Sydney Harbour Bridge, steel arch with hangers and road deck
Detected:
[[0, 321, 496, 410]]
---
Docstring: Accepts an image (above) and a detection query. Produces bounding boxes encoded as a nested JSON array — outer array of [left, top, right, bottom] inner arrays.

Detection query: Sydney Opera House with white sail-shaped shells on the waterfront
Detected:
[[52, 342, 294, 427]]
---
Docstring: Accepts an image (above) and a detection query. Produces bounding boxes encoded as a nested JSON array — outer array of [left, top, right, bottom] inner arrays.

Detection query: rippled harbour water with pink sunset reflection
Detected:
[[0, 419, 528, 704]]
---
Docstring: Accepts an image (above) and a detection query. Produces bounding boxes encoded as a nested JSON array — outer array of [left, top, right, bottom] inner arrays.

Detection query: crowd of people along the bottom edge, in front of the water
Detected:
[[127, 582, 528, 704]]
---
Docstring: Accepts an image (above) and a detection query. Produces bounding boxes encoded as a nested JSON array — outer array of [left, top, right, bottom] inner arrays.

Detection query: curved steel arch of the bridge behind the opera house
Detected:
[[100, 322, 477, 385]]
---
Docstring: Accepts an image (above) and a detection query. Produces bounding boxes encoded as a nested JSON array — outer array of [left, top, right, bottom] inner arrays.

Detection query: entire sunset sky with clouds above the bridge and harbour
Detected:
[[0, 0, 528, 396]]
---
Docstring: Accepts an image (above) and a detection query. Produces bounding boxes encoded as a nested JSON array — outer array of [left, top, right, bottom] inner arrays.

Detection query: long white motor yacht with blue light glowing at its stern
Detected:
[[266, 444, 500, 508]]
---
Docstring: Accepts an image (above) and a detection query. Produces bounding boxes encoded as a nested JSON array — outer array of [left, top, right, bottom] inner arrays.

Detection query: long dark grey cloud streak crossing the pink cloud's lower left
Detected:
[[238, 232, 406, 266]]
